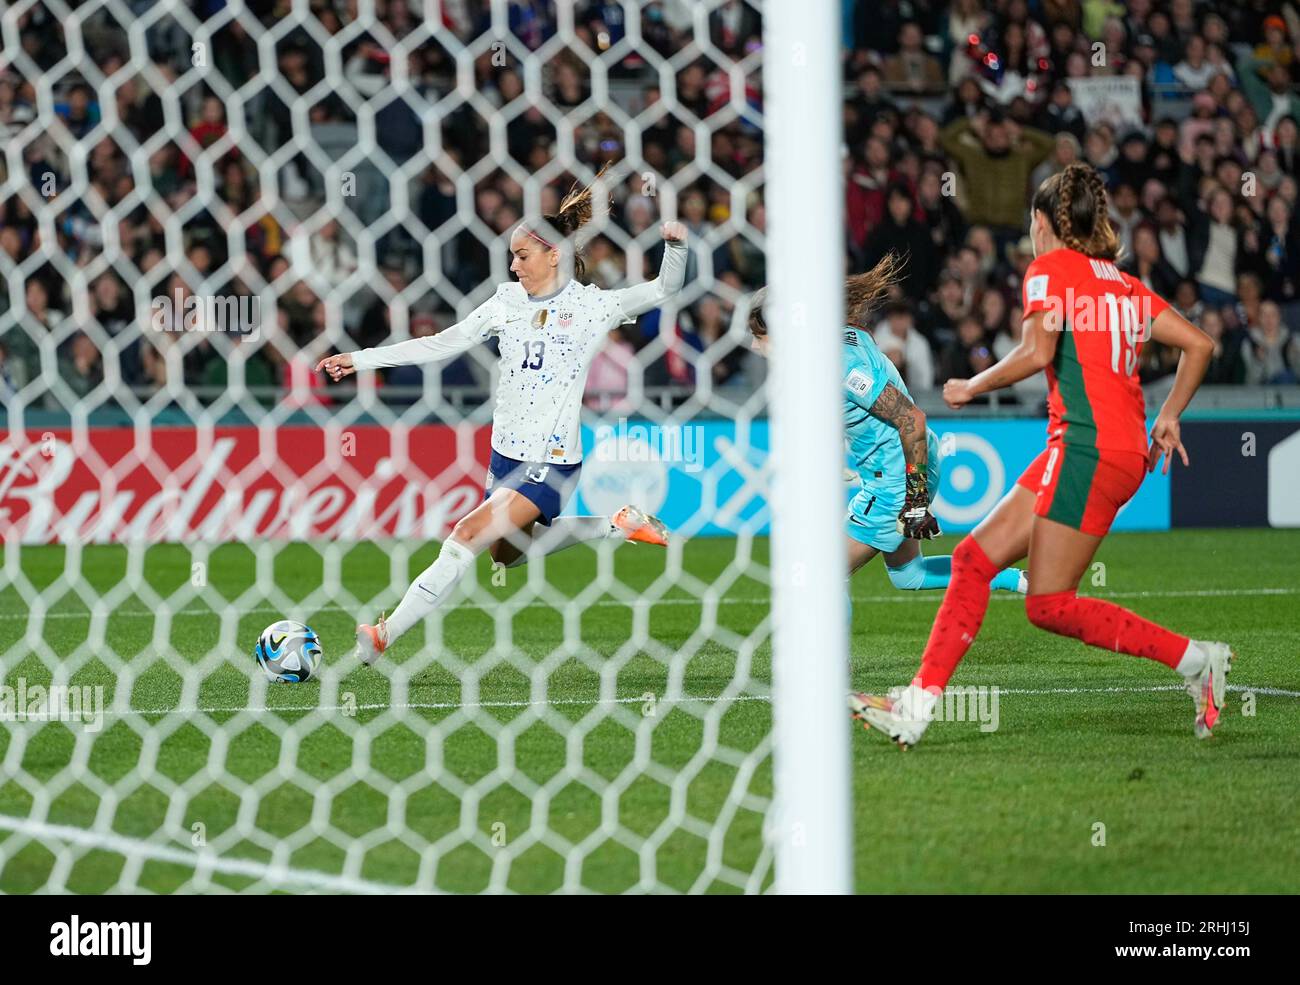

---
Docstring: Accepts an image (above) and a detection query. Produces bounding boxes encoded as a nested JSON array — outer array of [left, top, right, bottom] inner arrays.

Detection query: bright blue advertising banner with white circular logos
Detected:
[[567, 418, 1170, 537]]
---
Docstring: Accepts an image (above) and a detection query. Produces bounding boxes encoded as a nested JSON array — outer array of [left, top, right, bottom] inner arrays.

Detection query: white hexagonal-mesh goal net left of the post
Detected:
[[0, 0, 842, 893]]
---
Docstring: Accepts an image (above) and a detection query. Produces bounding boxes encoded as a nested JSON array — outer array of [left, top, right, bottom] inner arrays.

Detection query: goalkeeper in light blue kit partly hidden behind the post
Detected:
[[749, 253, 1026, 593]]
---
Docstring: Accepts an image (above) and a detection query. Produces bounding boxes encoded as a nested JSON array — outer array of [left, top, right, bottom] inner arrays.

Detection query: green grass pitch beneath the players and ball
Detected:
[[0, 530, 1300, 893]]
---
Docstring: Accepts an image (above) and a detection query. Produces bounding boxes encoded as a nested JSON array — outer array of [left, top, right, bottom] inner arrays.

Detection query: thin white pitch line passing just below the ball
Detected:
[[104, 684, 1300, 716]]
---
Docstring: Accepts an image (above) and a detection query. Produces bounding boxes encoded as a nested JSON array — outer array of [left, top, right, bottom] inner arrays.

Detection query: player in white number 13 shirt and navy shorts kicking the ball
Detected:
[[316, 174, 686, 664]]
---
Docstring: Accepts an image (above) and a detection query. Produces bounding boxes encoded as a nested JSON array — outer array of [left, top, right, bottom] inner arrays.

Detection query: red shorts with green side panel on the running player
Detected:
[[1017, 442, 1147, 537]]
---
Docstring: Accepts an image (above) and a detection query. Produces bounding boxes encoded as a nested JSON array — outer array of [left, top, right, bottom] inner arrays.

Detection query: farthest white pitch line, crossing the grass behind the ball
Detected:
[[0, 587, 1300, 621]]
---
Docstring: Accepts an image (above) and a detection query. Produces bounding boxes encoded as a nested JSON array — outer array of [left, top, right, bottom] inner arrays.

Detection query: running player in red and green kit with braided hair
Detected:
[[849, 164, 1232, 747]]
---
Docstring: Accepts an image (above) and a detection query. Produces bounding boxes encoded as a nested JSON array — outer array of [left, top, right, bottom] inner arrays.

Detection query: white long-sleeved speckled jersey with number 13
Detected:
[[352, 242, 686, 465]]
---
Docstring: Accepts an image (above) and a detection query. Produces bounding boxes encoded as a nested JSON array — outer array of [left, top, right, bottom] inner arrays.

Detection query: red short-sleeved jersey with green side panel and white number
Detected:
[[1023, 249, 1169, 455]]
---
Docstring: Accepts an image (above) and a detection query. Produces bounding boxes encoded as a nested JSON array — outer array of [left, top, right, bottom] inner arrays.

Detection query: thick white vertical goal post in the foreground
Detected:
[[763, 3, 853, 893]]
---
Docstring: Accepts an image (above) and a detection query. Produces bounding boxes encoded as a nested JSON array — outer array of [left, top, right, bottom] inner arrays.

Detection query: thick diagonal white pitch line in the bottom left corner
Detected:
[[0, 815, 413, 895]]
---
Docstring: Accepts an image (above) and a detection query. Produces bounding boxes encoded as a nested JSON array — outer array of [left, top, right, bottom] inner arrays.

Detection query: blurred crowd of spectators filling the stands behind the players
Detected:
[[0, 0, 1300, 418]]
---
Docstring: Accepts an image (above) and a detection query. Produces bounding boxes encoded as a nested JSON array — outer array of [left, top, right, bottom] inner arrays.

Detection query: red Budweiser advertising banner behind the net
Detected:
[[0, 425, 491, 543]]
